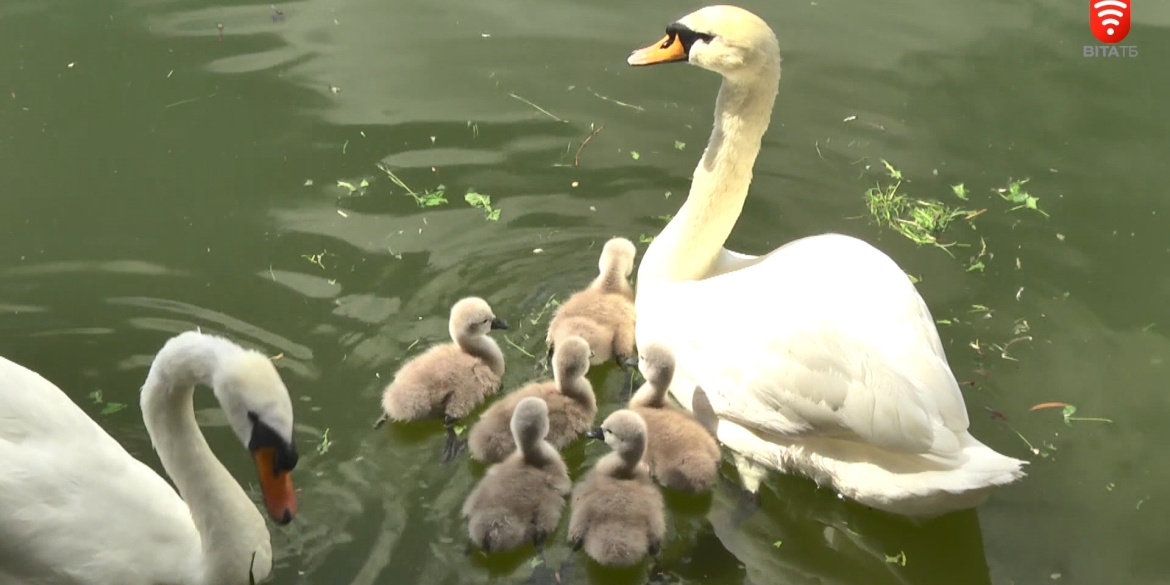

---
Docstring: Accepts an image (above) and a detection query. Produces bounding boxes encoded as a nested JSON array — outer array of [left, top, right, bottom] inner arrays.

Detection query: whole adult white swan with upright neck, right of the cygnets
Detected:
[[628, 6, 1025, 517]]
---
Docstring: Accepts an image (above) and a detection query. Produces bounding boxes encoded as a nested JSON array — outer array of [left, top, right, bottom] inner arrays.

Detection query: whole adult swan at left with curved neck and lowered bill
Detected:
[[0, 331, 297, 585]]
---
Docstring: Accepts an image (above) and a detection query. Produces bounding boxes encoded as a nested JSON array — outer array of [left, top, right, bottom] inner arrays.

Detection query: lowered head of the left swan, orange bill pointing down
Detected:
[[212, 351, 298, 524]]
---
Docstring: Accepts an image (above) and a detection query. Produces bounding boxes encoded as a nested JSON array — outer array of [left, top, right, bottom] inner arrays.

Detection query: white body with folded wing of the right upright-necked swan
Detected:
[[638, 234, 968, 454]]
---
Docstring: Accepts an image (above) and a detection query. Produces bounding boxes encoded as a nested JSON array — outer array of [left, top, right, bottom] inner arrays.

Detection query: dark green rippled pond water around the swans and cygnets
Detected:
[[0, 0, 1170, 585]]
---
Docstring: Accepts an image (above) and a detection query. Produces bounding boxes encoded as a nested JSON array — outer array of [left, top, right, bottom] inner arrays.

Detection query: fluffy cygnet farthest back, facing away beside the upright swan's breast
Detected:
[[545, 238, 638, 373]]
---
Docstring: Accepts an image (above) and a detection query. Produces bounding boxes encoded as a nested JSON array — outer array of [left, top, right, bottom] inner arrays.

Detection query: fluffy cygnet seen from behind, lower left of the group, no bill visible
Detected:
[[463, 397, 572, 552]]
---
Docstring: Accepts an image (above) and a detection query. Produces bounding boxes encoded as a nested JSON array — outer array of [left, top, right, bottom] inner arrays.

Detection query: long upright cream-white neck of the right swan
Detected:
[[638, 65, 780, 285]]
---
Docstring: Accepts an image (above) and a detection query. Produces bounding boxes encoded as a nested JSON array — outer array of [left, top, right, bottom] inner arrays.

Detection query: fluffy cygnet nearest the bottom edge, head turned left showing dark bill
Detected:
[[569, 410, 666, 566]]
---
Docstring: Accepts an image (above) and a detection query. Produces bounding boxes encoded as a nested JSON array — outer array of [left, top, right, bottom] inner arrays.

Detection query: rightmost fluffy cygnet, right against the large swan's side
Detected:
[[629, 344, 721, 494]]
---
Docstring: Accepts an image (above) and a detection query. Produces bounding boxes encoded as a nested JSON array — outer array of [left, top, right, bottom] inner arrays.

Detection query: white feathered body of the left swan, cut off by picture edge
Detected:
[[0, 358, 200, 585]]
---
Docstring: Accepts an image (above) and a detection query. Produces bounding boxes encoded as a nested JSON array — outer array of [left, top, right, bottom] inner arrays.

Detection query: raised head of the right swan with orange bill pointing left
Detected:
[[626, 5, 780, 78]]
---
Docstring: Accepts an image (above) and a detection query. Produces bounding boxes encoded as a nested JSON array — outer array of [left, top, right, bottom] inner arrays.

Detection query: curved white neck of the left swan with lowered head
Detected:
[[142, 332, 270, 584]]
